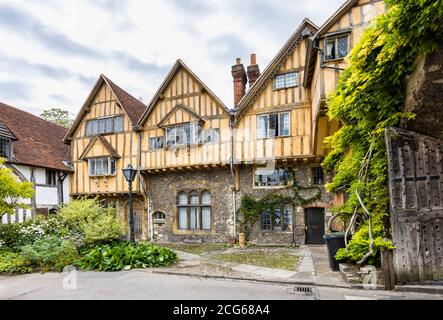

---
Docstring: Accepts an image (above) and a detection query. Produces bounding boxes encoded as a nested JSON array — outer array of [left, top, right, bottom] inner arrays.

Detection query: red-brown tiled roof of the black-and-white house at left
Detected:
[[0, 102, 70, 171]]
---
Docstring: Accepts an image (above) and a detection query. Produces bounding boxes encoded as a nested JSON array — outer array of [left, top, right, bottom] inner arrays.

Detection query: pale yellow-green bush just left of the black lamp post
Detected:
[[60, 198, 125, 244]]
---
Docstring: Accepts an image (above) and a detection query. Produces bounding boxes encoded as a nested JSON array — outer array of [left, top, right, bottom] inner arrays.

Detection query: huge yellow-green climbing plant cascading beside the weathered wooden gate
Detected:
[[323, 0, 443, 263]]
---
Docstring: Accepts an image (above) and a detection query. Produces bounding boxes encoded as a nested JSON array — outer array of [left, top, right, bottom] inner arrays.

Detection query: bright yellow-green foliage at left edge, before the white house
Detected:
[[0, 158, 34, 219]]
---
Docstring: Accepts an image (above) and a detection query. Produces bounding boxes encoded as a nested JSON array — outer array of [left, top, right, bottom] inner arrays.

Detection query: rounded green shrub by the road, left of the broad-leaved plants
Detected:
[[21, 237, 79, 272]]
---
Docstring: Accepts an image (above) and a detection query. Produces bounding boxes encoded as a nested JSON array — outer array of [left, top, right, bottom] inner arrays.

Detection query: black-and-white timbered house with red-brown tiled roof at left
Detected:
[[0, 103, 72, 223]]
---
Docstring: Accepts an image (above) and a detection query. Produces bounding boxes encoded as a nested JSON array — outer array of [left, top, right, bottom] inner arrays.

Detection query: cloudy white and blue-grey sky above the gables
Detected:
[[0, 0, 344, 116]]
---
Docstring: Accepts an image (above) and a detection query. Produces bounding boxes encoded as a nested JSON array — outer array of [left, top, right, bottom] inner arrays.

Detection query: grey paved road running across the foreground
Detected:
[[0, 271, 443, 300]]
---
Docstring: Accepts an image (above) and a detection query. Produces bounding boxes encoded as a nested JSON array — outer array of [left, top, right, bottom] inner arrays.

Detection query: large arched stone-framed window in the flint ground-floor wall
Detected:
[[177, 190, 212, 230]]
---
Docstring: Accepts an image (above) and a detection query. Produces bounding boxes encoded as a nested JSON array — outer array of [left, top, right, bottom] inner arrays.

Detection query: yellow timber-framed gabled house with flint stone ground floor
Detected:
[[65, 0, 385, 244]]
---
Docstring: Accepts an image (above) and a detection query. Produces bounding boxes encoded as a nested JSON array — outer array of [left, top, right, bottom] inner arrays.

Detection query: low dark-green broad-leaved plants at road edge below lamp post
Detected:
[[80, 242, 177, 271]]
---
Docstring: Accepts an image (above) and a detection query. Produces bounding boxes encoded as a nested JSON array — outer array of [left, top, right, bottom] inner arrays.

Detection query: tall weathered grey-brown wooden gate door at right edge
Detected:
[[385, 128, 443, 283]]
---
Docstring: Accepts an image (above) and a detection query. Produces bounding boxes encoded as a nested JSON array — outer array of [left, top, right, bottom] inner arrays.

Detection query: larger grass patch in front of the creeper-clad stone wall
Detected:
[[214, 251, 299, 271]]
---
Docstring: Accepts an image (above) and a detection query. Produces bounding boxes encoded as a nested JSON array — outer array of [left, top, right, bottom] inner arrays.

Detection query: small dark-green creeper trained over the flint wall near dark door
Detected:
[[238, 169, 322, 236]]
